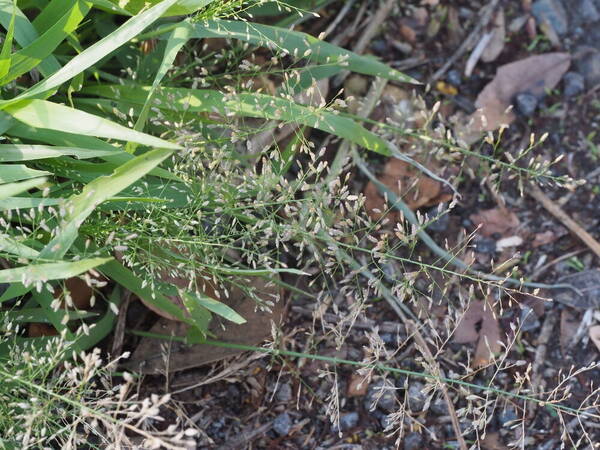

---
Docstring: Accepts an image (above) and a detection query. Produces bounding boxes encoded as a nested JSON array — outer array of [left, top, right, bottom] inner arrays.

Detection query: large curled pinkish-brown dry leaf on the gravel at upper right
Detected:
[[457, 52, 571, 144]]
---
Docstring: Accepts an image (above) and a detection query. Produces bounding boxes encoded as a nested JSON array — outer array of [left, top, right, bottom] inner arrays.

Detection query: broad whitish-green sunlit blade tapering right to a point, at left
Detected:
[[5, 99, 180, 149]]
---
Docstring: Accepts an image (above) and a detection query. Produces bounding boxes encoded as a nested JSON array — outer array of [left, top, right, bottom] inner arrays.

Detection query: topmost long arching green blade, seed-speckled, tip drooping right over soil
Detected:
[[192, 20, 420, 84]]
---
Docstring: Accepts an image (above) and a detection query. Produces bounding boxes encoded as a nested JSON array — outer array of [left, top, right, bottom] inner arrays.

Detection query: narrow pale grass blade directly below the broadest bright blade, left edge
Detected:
[[0, 144, 119, 162]]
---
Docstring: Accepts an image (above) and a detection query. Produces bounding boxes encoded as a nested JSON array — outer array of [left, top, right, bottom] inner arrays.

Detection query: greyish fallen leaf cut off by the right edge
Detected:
[[548, 269, 600, 310]]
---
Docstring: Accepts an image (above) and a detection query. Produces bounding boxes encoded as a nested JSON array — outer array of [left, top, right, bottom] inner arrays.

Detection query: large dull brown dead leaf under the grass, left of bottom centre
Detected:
[[124, 278, 284, 374]]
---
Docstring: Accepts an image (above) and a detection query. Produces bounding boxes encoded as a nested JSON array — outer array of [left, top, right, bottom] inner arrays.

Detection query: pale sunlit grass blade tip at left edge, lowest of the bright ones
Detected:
[[0, 258, 112, 284]]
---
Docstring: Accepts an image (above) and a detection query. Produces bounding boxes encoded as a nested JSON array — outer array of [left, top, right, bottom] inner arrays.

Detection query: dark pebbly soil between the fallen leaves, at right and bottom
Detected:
[[119, 0, 600, 449]]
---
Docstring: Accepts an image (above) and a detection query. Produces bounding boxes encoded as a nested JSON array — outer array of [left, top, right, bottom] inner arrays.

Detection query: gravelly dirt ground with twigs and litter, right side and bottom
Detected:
[[126, 0, 600, 449]]
